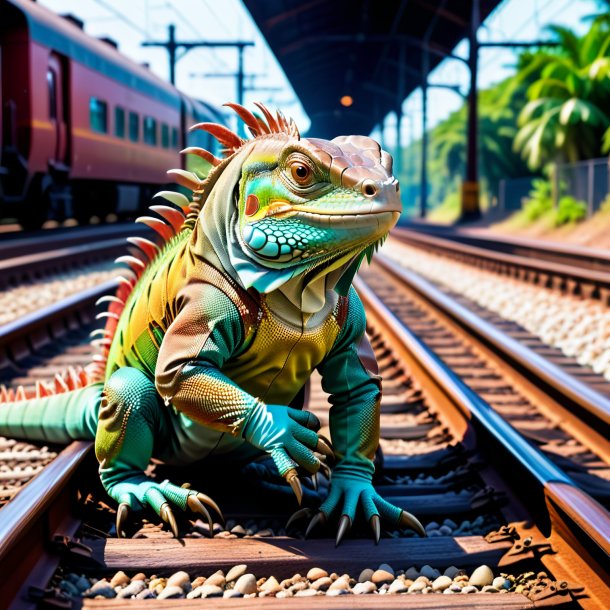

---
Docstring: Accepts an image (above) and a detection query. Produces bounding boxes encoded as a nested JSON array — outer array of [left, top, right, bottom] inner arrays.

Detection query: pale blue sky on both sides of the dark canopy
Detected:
[[39, 0, 599, 139]]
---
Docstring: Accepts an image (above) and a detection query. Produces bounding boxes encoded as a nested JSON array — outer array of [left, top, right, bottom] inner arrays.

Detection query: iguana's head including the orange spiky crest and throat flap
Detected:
[[182, 104, 402, 300]]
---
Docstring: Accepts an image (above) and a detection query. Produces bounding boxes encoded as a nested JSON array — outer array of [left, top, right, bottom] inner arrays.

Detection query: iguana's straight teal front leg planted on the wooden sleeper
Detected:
[[308, 289, 425, 545]]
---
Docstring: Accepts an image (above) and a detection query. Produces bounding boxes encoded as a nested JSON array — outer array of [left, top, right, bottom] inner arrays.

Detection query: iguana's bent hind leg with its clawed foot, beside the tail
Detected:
[[95, 367, 220, 537]]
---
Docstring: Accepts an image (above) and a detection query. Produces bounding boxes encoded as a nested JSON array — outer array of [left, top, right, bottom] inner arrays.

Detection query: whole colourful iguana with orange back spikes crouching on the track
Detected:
[[0, 104, 425, 544]]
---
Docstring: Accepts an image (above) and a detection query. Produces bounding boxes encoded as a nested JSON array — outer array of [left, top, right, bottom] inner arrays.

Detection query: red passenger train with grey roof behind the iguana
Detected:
[[0, 0, 225, 230]]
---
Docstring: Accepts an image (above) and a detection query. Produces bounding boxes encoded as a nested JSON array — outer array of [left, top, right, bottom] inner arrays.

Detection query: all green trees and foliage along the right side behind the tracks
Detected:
[[400, 10, 610, 218]]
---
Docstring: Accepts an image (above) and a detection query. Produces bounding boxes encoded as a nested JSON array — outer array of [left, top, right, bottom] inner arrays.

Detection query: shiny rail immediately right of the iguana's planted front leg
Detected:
[[354, 274, 610, 571]]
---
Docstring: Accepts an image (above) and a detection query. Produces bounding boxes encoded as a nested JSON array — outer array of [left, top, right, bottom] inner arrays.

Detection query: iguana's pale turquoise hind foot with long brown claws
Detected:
[[109, 477, 224, 538]]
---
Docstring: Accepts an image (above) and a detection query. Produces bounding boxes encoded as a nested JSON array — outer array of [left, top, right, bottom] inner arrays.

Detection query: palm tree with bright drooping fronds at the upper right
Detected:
[[514, 22, 610, 170]]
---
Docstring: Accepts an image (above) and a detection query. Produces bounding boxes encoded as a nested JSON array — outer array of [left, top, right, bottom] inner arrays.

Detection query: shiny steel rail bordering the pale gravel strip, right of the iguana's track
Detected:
[[375, 254, 610, 426]]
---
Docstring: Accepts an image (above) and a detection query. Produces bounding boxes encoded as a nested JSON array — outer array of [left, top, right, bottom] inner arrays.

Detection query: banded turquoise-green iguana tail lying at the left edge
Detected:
[[0, 382, 104, 444]]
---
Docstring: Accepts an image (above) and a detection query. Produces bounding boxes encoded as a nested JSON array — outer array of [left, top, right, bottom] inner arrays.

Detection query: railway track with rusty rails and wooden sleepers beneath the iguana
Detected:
[[0, 255, 610, 608]]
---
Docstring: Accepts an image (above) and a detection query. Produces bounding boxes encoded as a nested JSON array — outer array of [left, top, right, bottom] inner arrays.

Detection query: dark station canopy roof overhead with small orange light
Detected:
[[244, 0, 500, 138]]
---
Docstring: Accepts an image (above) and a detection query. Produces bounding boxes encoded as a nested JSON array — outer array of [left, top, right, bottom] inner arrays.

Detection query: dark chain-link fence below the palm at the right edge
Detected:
[[498, 157, 610, 216]]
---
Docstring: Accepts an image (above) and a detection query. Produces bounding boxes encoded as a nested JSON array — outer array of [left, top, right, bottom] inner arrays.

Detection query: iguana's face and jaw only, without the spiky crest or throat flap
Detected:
[[238, 136, 401, 267]]
